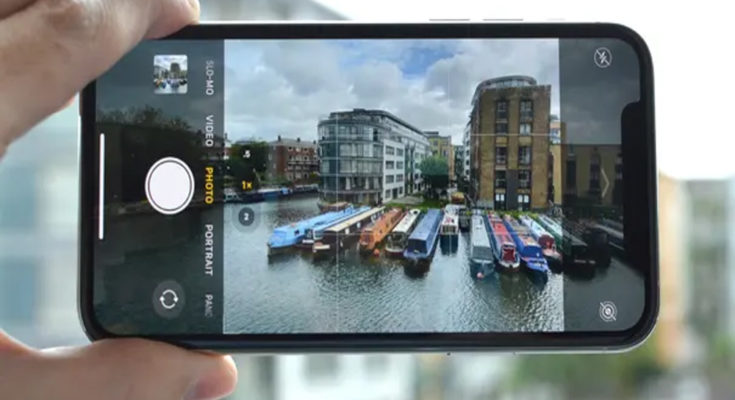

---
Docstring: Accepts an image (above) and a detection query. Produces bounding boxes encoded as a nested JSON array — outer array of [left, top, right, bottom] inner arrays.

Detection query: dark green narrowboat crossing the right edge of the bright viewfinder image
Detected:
[[536, 214, 597, 275]]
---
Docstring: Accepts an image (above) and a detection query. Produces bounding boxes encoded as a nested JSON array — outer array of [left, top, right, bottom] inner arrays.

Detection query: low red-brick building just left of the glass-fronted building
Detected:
[[268, 135, 319, 183]]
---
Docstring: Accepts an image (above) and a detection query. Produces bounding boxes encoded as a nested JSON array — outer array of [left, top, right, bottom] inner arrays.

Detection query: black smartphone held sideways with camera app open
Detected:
[[79, 23, 659, 352]]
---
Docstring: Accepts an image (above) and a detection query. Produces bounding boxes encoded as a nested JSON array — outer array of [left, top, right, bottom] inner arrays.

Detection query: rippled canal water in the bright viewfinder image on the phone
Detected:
[[224, 197, 564, 333]]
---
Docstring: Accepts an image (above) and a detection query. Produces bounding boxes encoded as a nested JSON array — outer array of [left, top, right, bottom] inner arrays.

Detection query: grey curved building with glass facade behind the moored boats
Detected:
[[318, 109, 431, 204]]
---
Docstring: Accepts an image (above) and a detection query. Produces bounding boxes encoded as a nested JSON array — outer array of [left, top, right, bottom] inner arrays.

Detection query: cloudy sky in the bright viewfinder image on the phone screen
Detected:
[[225, 39, 559, 144]]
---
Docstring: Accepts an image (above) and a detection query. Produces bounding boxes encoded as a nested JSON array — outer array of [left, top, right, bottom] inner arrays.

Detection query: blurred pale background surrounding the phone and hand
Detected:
[[0, 0, 735, 400]]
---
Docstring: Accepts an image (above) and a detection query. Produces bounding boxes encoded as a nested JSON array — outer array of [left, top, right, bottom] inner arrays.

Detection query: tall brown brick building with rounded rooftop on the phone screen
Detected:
[[470, 76, 551, 210]]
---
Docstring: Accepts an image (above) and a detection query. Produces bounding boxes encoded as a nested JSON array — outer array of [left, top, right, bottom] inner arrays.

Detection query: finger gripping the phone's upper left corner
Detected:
[[0, 0, 199, 148]]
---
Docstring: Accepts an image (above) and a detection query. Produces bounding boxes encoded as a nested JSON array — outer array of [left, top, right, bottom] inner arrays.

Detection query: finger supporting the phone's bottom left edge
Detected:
[[0, 331, 237, 400]]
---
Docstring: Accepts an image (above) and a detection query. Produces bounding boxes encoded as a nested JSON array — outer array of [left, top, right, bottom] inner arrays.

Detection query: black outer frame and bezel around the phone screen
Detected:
[[79, 22, 659, 353]]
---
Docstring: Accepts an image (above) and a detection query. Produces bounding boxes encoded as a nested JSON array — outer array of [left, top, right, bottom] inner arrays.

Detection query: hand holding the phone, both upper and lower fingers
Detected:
[[0, 0, 237, 400]]
